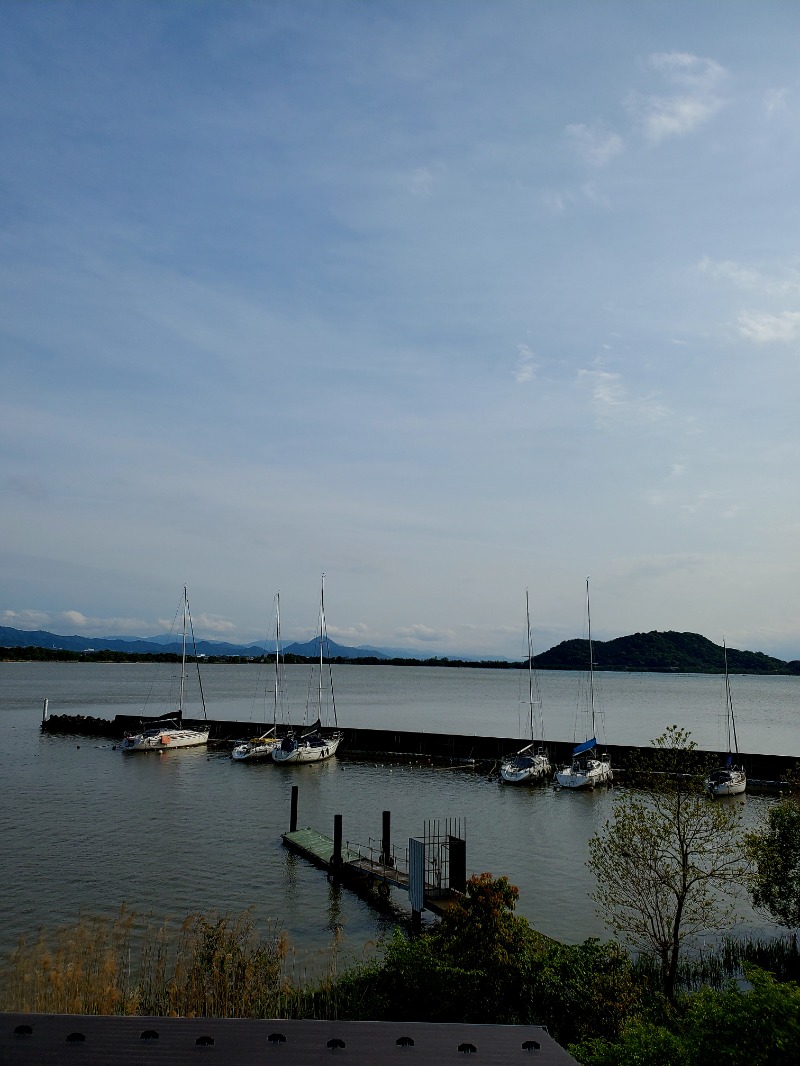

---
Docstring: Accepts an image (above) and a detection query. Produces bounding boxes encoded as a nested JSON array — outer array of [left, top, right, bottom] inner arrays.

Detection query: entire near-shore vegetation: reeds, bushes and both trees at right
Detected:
[[9, 726, 800, 1066]]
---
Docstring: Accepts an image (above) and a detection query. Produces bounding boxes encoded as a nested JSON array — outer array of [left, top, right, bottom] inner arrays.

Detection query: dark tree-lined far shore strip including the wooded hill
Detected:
[[0, 632, 800, 676]]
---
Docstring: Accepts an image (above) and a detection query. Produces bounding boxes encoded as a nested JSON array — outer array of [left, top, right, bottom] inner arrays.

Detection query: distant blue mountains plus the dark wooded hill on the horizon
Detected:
[[0, 626, 800, 674]]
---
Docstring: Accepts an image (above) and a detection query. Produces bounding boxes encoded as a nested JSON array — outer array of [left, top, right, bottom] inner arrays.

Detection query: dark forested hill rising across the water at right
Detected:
[[535, 631, 800, 674]]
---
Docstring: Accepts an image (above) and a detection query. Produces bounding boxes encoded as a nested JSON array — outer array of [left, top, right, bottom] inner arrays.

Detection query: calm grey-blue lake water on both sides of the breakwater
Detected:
[[0, 663, 800, 965]]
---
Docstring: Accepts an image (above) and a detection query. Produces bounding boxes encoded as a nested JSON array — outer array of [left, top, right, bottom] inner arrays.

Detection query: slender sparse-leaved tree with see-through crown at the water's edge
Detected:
[[589, 726, 745, 999]]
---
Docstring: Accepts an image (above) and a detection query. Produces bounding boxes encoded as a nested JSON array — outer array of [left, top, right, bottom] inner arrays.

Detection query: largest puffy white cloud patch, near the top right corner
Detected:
[[626, 52, 726, 144]]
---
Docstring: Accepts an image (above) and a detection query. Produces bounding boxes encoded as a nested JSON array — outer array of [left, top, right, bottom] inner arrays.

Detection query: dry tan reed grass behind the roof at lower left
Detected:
[[0, 909, 349, 1018]]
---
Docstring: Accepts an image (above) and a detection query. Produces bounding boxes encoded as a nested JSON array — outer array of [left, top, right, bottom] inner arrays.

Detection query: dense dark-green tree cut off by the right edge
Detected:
[[745, 800, 800, 928]]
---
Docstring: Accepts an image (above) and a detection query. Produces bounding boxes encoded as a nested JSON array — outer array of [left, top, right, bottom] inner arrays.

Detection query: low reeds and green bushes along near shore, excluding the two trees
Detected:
[[0, 874, 800, 1066]]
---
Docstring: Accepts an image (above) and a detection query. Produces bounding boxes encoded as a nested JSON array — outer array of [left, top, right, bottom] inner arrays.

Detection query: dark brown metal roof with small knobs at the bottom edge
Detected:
[[0, 1014, 576, 1066]]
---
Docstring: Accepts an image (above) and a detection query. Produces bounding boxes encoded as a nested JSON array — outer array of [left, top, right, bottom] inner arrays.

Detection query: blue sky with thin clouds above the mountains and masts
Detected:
[[0, 0, 800, 659]]
